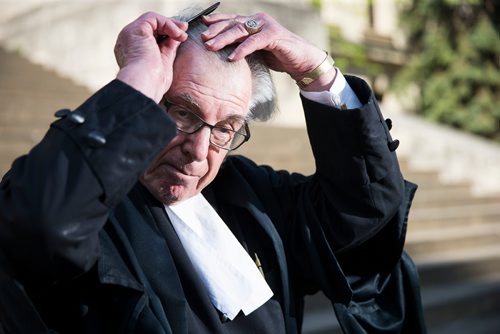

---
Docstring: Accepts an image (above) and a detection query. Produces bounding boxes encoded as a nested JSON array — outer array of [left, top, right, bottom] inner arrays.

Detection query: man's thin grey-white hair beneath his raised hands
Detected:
[[176, 7, 276, 121]]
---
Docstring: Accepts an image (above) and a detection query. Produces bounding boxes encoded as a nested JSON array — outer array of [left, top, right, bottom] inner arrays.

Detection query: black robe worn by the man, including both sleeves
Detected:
[[0, 78, 425, 333]]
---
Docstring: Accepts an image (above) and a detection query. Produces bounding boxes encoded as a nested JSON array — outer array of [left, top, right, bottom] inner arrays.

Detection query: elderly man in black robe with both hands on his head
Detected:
[[0, 3, 425, 334]]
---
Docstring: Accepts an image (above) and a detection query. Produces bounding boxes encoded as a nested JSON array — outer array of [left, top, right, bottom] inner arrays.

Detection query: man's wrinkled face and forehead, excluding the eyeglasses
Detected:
[[141, 47, 252, 205]]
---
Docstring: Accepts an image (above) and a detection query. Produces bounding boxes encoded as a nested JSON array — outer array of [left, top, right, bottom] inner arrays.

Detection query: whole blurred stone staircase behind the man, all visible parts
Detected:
[[0, 49, 500, 334]]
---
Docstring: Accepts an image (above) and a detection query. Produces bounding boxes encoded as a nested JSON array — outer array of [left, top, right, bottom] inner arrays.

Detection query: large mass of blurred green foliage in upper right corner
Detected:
[[395, 0, 500, 142]]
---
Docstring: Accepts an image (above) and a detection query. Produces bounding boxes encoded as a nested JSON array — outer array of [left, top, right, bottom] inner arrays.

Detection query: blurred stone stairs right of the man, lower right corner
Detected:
[[406, 167, 500, 334]]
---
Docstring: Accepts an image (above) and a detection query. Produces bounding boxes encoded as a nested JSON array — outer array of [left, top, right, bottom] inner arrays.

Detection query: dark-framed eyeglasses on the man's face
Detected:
[[163, 100, 250, 151]]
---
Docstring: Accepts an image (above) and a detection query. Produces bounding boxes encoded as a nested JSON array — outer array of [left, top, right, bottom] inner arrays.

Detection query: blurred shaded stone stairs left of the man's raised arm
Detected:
[[0, 48, 90, 176]]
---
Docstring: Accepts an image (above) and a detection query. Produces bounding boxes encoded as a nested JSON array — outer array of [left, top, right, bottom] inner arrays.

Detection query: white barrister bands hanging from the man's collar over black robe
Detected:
[[165, 194, 273, 320]]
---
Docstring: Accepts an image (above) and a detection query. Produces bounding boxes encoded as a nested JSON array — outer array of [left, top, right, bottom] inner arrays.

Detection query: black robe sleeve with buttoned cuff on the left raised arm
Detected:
[[0, 80, 176, 285]]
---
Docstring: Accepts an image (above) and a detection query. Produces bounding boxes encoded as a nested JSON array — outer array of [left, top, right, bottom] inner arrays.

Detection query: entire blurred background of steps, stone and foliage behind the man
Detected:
[[0, 0, 500, 334]]
